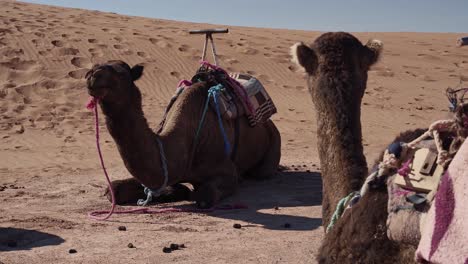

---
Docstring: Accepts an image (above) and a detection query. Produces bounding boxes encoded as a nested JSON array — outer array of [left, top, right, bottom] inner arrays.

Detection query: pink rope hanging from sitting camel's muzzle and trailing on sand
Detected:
[[86, 97, 247, 221]]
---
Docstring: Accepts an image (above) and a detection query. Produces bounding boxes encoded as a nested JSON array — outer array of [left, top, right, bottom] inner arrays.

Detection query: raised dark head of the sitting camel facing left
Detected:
[[86, 60, 143, 102]]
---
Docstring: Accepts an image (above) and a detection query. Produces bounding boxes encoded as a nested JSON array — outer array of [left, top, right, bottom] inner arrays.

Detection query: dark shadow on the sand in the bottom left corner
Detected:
[[0, 227, 65, 252]]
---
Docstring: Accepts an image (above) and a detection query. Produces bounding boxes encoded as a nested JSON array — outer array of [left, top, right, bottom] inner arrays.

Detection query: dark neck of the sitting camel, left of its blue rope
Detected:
[[101, 89, 187, 189]]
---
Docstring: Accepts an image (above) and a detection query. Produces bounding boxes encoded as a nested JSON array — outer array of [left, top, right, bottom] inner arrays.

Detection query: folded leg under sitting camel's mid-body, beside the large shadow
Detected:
[[192, 159, 239, 208]]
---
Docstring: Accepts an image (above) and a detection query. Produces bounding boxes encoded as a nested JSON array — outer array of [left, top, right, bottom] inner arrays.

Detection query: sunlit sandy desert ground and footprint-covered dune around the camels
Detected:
[[0, 1, 468, 263]]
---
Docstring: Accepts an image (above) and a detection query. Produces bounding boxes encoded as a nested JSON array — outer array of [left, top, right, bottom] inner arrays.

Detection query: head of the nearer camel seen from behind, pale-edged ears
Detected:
[[291, 32, 383, 99]]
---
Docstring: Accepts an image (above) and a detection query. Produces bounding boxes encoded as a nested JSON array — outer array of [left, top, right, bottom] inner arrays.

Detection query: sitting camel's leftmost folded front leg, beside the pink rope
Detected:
[[104, 178, 145, 204]]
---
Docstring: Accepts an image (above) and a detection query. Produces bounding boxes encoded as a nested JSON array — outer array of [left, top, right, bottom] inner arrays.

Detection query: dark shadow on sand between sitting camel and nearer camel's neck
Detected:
[[210, 171, 322, 231]]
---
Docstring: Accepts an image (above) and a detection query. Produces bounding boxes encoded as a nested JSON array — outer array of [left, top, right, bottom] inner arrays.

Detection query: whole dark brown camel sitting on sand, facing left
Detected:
[[86, 61, 281, 208]]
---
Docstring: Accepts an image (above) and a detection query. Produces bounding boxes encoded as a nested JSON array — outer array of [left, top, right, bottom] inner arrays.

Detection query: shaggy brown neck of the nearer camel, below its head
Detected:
[[312, 80, 367, 226]]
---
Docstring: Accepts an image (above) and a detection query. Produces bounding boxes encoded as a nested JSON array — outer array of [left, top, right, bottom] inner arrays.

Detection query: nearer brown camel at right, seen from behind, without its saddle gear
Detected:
[[291, 32, 424, 263]]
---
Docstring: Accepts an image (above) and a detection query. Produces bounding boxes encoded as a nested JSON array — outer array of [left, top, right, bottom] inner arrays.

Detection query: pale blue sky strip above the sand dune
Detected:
[[22, 0, 468, 33]]
